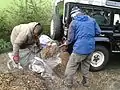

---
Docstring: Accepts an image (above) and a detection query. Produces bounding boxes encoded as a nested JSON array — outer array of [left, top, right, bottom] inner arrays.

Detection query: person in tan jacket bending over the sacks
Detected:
[[11, 22, 42, 64]]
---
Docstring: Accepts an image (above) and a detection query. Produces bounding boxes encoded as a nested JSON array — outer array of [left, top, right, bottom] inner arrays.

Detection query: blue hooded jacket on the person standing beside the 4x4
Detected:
[[67, 15, 101, 54]]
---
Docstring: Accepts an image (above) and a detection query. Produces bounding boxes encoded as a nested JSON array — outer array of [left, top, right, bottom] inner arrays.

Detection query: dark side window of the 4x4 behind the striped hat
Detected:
[[66, 3, 113, 27]]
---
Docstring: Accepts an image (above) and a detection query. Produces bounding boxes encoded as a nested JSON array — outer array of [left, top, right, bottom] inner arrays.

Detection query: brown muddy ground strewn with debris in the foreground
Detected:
[[0, 53, 120, 90]]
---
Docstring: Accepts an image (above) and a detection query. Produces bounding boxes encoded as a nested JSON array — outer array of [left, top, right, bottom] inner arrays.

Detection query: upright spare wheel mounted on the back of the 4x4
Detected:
[[50, 14, 63, 40]]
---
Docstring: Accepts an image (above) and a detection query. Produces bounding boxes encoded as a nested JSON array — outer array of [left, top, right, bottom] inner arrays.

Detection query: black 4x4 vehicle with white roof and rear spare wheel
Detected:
[[51, 0, 120, 71]]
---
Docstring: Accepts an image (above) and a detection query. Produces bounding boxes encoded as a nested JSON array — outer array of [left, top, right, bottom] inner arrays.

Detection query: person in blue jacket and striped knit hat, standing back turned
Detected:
[[65, 7, 101, 87]]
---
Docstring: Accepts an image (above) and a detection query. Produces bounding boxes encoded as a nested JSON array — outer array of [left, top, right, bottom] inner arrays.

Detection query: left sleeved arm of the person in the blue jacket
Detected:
[[66, 21, 75, 45]]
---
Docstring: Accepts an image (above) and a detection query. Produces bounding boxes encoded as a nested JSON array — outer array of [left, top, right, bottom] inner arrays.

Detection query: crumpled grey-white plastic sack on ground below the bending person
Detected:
[[7, 49, 61, 78]]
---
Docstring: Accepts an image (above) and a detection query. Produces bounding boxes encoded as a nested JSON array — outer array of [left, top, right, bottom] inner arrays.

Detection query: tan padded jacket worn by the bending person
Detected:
[[11, 22, 38, 55]]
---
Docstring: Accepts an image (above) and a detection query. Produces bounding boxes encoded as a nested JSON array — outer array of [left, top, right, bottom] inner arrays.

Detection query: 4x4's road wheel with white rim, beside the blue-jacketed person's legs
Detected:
[[90, 46, 109, 71]]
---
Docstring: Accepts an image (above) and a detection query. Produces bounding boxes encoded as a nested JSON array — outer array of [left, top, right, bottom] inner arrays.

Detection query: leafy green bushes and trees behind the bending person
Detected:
[[0, 0, 53, 53]]
